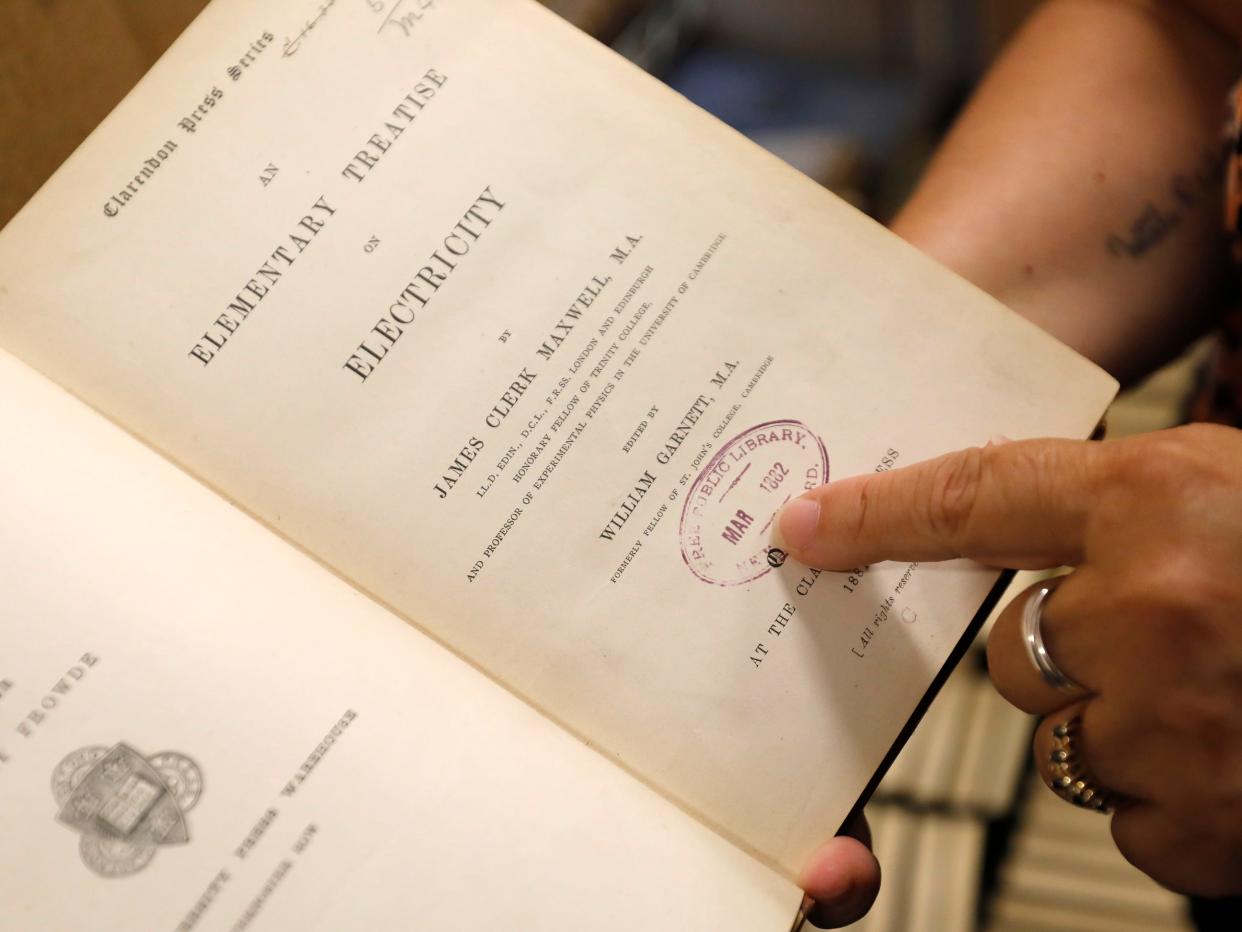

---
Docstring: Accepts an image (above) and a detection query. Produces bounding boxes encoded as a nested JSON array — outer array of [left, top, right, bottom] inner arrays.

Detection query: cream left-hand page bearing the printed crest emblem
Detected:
[[0, 353, 801, 932]]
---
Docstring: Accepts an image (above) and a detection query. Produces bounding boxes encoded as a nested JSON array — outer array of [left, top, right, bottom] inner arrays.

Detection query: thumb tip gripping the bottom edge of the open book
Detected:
[[799, 816, 879, 928]]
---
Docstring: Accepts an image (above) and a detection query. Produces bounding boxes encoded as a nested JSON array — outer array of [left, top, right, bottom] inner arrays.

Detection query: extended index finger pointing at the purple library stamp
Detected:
[[777, 440, 1100, 569]]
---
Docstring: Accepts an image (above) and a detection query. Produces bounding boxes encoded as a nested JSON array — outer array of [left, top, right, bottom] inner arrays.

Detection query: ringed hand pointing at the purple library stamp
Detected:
[[779, 426, 1242, 896]]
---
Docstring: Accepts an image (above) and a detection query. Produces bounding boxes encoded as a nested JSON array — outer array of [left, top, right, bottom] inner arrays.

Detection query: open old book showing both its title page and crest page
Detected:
[[0, 0, 1115, 932]]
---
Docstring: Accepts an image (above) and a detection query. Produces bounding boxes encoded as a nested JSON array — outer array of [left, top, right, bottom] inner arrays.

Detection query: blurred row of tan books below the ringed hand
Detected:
[[851, 569, 1192, 932]]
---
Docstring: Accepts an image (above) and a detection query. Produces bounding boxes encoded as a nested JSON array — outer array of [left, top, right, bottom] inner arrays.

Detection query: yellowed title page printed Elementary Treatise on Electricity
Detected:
[[0, 0, 1115, 874]]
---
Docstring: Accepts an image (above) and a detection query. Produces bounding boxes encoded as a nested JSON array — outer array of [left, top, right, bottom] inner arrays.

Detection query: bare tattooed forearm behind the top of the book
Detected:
[[893, 0, 1242, 380]]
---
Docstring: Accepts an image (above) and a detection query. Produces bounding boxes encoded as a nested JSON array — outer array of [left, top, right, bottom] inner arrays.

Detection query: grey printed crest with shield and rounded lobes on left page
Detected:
[[52, 743, 202, 877]]
